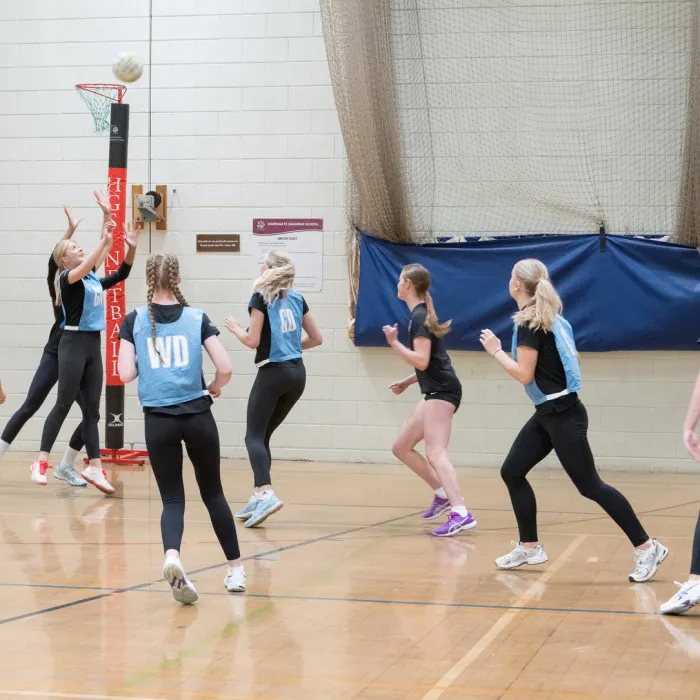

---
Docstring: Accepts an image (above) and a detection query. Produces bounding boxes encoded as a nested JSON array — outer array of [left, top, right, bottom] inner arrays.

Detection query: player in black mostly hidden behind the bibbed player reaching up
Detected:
[[0, 207, 106, 486]]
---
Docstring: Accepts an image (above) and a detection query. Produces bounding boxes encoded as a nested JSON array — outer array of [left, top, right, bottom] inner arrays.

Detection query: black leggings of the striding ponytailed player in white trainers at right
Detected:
[[501, 401, 649, 547]]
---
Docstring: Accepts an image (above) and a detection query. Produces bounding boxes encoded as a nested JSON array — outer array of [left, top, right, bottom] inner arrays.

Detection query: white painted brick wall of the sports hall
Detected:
[[0, 0, 698, 470]]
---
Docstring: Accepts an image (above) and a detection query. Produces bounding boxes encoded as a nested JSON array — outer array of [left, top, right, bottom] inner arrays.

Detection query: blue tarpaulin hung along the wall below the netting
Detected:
[[355, 234, 700, 352]]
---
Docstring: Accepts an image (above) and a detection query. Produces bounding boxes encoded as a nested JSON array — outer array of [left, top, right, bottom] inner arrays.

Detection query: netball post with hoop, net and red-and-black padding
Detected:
[[75, 83, 148, 467]]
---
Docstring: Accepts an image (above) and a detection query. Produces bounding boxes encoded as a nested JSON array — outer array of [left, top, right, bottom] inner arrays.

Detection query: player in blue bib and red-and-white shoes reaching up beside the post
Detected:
[[31, 193, 138, 494]]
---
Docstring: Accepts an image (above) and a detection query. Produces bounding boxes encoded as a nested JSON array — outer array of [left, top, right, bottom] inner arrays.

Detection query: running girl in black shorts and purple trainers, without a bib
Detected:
[[383, 265, 476, 537]]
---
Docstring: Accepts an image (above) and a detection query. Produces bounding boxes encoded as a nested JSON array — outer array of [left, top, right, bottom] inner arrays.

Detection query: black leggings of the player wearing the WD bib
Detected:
[[145, 410, 241, 561]]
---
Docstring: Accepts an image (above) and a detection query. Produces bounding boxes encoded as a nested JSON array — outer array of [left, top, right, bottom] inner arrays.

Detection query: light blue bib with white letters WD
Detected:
[[134, 306, 207, 406]]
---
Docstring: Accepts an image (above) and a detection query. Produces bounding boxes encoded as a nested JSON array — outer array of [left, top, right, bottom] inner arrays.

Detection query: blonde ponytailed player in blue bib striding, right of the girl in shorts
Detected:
[[480, 260, 668, 583]]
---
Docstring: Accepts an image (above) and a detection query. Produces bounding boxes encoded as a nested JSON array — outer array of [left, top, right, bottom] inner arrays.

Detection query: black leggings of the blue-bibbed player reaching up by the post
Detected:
[[41, 331, 102, 459]]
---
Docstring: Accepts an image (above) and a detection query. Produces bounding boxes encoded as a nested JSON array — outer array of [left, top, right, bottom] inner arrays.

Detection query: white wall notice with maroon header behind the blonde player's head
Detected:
[[253, 219, 323, 292]]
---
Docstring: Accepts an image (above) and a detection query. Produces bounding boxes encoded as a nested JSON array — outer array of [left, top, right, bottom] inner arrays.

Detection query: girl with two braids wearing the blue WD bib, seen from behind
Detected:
[[119, 253, 246, 605]]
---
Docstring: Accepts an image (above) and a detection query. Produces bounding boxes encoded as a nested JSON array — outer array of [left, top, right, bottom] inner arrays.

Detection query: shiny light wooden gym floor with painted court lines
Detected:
[[0, 454, 700, 700]]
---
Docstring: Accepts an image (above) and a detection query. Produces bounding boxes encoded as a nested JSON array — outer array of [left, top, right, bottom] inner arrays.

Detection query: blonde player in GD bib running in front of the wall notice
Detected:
[[226, 250, 323, 527]]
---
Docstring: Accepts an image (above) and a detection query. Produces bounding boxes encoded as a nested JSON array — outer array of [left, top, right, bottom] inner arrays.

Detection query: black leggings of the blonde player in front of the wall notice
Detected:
[[245, 358, 306, 487]]
